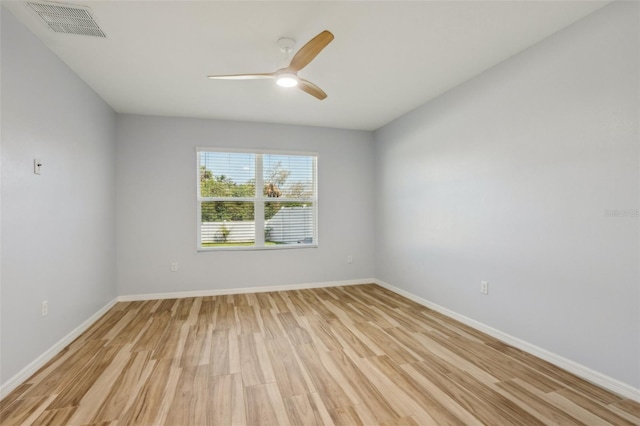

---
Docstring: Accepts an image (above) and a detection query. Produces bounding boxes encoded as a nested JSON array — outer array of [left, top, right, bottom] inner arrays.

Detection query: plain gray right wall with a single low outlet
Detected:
[[375, 2, 640, 388]]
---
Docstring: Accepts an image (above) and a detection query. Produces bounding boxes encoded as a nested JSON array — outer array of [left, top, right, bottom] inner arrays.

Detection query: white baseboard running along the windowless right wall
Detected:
[[374, 279, 640, 402]]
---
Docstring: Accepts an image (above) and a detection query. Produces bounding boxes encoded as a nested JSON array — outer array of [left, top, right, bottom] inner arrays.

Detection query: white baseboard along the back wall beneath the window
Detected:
[[118, 278, 376, 302]]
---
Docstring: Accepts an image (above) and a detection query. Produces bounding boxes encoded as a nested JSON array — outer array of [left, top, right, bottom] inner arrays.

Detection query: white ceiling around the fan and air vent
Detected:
[[3, 1, 608, 130]]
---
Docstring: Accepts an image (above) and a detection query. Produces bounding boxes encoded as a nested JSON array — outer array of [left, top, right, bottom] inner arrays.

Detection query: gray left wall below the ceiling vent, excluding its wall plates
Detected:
[[0, 10, 116, 383]]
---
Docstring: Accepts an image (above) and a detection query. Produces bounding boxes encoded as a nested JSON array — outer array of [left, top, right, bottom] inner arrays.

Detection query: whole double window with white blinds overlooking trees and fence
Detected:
[[198, 148, 318, 250]]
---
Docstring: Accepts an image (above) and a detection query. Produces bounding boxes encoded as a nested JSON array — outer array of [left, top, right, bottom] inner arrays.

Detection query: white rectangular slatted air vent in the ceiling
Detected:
[[27, 2, 106, 37]]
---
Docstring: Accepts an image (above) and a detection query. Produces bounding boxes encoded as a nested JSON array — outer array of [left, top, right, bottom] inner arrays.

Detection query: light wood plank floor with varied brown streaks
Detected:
[[0, 285, 640, 426]]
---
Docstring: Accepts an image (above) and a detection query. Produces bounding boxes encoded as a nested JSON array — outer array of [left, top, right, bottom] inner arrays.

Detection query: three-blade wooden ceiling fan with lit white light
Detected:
[[208, 30, 333, 100]]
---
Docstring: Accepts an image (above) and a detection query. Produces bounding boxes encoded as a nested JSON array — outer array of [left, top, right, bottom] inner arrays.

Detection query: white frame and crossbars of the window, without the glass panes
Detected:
[[195, 147, 319, 252]]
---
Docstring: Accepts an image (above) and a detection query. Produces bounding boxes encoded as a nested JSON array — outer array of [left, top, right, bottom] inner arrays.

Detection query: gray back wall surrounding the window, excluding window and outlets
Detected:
[[117, 115, 374, 295]]
